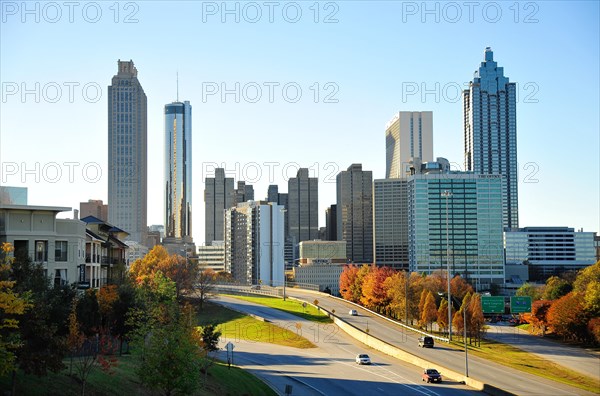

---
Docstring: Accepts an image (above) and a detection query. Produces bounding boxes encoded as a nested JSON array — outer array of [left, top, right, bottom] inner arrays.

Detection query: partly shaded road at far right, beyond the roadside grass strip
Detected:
[[485, 324, 600, 379]]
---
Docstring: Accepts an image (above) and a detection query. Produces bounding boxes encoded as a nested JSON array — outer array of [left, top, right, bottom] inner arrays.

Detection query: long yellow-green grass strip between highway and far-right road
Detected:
[[451, 340, 600, 393]]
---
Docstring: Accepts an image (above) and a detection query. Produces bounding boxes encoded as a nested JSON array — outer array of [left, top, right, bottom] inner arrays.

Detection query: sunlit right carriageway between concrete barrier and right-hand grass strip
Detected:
[[286, 288, 594, 396]]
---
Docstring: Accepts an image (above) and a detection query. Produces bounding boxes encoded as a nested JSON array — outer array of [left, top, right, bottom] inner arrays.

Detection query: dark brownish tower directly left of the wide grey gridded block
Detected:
[[336, 164, 373, 263]]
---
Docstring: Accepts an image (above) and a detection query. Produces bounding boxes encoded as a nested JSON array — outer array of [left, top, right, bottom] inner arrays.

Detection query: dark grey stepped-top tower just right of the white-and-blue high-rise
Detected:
[[287, 168, 319, 245]]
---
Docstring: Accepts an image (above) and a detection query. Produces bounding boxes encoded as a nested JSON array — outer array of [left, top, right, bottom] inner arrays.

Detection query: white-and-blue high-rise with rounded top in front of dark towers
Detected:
[[225, 201, 284, 286]]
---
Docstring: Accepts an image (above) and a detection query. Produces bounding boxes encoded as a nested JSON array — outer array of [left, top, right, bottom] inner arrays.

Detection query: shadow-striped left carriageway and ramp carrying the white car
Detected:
[[211, 296, 481, 396]]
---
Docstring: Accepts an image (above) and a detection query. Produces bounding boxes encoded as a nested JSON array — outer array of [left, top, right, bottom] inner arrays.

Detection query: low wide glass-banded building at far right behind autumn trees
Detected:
[[504, 227, 597, 281]]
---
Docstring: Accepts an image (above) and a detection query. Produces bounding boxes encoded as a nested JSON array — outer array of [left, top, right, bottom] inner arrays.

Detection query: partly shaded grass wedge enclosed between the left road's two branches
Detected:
[[197, 303, 316, 349]]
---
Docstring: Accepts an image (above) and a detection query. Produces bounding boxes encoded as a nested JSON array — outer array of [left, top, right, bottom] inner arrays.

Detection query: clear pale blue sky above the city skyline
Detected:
[[0, 0, 600, 245]]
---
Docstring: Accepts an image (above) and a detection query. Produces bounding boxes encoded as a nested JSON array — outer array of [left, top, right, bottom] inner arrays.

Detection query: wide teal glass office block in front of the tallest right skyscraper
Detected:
[[407, 163, 504, 291]]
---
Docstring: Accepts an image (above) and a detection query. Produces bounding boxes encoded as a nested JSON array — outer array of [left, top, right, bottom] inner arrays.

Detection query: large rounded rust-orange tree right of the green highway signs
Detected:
[[547, 292, 588, 341]]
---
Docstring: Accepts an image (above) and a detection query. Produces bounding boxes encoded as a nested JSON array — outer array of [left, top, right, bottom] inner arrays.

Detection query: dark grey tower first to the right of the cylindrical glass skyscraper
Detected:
[[204, 168, 236, 245]]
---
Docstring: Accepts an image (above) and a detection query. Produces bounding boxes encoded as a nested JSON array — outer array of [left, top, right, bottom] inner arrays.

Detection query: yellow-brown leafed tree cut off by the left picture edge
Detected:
[[0, 242, 31, 377]]
